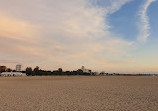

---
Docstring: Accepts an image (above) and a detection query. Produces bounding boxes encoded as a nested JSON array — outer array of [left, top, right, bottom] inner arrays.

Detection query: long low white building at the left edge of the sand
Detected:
[[0, 72, 26, 77]]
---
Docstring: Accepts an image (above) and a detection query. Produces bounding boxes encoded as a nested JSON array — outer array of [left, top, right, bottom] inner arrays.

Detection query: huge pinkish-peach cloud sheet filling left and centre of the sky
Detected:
[[0, 0, 133, 70]]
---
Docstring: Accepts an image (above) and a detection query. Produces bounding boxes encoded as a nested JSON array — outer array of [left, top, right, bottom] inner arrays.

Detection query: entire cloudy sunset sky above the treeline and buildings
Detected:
[[0, 0, 158, 73]]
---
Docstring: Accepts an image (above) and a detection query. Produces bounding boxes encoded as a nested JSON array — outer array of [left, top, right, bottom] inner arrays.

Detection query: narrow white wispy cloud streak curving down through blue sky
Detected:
[[138, 0, 156, 42]]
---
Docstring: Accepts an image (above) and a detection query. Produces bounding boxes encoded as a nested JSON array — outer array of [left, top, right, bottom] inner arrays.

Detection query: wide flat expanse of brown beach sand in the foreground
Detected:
[[0, 76, 158, 111]]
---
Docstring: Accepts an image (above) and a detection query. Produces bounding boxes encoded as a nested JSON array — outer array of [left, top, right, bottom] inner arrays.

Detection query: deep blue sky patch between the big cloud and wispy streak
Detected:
[[109, 0, 142, 41]]
